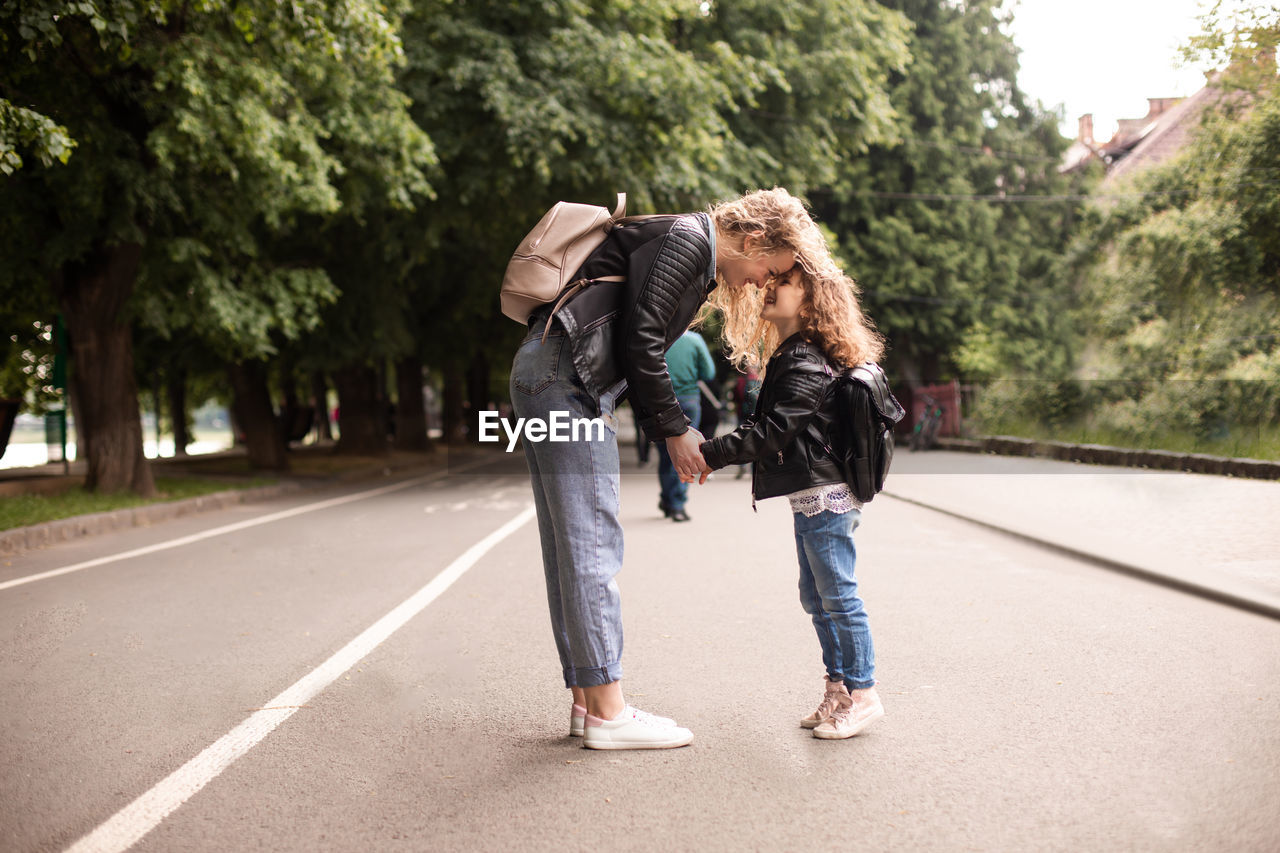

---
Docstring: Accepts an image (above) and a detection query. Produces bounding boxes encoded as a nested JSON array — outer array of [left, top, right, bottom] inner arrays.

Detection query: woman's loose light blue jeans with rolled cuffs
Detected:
[[511, 315, 625, 686]]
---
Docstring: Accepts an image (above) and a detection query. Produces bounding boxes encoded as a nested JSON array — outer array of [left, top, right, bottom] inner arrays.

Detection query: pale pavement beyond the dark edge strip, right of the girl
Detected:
[[886, 450, 1280, 616]]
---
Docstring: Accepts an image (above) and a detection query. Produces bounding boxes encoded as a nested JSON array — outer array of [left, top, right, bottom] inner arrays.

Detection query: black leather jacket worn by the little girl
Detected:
[[701, 332, 845, 501]]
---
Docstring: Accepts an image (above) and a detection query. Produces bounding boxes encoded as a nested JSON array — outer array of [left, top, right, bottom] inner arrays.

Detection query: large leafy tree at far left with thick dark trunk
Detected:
[[0, 0, 431, 493]]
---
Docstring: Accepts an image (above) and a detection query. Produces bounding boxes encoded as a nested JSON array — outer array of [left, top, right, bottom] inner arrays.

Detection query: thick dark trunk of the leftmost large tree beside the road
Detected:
[[54, 243, 156, 497]]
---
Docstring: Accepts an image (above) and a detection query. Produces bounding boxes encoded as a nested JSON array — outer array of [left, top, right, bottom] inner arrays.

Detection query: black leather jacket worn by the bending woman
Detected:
[[530, 214, 716, 441]]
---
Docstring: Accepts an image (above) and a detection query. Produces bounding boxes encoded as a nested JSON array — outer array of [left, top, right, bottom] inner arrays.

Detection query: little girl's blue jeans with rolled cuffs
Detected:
[[795, 510, 876, 690]]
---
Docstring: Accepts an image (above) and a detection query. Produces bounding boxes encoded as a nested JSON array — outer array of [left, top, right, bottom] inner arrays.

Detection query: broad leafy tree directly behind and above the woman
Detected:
[[403, 0, 906, 438]]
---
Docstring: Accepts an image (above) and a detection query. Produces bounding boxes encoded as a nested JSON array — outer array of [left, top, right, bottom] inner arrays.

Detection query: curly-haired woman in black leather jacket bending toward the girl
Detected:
[[511, 190, 822, 749]]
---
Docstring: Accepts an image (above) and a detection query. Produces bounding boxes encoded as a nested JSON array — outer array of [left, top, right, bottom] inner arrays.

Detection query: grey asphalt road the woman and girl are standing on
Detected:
[[0, 452, 1280, 853]]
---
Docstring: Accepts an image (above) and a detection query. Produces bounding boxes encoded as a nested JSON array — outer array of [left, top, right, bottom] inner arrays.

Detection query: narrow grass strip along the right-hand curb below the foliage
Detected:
[[967, 420, 1280, 460]]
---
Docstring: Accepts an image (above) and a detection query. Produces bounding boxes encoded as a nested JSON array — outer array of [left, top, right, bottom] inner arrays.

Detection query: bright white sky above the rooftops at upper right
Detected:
[[1005, 0, 1204, 142]]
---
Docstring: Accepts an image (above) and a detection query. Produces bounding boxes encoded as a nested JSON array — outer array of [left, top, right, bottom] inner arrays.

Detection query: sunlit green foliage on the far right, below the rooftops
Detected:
[[1013, 12, 1280, 446]]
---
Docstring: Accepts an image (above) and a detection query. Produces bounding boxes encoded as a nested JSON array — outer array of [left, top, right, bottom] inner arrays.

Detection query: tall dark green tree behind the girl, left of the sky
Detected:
[[815, 0, 1080, 383]]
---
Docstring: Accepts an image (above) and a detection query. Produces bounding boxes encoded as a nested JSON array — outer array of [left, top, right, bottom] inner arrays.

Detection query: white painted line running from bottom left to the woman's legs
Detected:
[[68, 506, 534, 853]]
